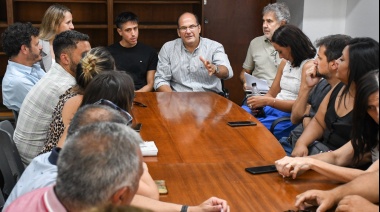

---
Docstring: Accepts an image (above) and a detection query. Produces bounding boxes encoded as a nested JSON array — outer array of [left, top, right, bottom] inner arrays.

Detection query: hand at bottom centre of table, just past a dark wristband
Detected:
[[187, 197, 230, 212]]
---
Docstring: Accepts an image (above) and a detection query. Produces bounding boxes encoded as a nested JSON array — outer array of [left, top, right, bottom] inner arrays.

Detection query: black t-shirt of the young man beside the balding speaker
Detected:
[[108, 42, 158, 90]]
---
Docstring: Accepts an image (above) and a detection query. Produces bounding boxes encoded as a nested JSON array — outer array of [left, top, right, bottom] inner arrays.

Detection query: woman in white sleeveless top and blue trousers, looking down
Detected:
[[242, 25, 316, 139]]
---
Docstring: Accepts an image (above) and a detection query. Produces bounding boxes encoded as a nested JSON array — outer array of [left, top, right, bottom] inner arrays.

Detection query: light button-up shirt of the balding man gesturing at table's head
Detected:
[[154, 37, 233, 93]]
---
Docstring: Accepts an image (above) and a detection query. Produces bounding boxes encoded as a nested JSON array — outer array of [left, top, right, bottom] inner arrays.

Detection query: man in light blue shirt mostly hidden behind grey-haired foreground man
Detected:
[[5, 105, 228, 211]]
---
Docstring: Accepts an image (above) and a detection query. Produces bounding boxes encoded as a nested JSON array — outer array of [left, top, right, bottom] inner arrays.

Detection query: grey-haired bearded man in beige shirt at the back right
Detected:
[[240, 3, 290, 90]]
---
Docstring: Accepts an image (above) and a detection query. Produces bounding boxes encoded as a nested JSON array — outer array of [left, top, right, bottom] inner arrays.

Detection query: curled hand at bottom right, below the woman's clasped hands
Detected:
[[295, 190, 336, 212]]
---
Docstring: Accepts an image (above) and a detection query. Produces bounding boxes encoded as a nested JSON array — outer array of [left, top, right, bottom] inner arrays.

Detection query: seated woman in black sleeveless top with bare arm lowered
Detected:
[[291, 38, 379, 157]]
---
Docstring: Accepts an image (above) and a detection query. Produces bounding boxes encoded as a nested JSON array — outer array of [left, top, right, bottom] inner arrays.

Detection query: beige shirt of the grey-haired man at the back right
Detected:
[[243, 35, 281, 87]]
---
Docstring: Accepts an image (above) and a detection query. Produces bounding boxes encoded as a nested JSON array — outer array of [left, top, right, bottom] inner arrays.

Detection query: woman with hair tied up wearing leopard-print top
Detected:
[[40, 47, 115, 154]]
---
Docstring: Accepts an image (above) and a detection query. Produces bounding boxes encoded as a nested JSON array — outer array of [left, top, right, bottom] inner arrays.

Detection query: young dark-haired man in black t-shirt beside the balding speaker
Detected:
[[108, 12, 158, 92]]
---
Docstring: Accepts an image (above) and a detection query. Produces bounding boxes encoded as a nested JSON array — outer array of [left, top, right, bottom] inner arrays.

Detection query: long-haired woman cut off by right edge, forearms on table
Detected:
[[276, 70, 379, 182]]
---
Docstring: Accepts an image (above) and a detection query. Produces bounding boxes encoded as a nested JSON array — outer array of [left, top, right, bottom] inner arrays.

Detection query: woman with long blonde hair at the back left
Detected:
[[39, 4, 74, 72]]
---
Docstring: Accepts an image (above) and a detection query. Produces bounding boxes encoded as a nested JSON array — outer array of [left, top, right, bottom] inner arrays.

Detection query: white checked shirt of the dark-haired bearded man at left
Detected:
[[13, 63, 76, 165]]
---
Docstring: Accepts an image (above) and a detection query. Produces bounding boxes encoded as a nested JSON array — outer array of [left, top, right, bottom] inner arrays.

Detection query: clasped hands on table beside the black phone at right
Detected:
[[275, 156, 312, 179]]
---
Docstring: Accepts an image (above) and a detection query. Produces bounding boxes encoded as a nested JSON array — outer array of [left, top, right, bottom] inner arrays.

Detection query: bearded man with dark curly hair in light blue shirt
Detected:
[[2, 23, 45, 113]]
